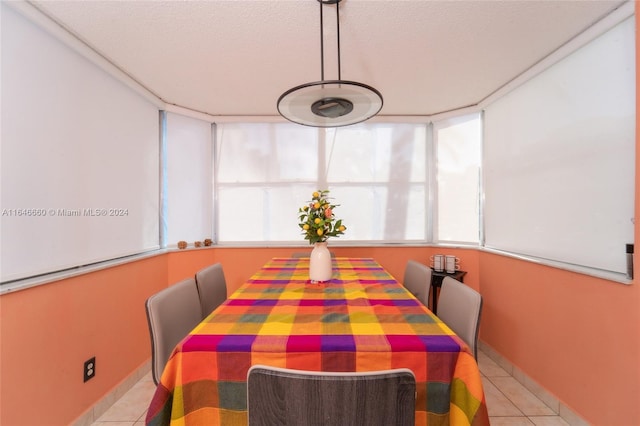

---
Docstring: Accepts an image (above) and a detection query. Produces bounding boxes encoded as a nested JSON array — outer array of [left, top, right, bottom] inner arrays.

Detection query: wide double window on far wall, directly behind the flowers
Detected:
[[215, 123, 429, 243]]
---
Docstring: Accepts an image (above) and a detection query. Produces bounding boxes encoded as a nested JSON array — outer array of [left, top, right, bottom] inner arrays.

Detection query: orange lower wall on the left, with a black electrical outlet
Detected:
[[0, 256, 167, 426]]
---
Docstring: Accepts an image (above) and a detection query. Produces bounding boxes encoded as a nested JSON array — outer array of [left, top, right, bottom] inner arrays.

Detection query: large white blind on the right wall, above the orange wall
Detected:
[[484, 18, 636, 272]]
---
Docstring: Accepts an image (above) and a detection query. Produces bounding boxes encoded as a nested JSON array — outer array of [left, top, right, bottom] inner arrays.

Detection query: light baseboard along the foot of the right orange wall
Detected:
[[478, 341, 589, 426]]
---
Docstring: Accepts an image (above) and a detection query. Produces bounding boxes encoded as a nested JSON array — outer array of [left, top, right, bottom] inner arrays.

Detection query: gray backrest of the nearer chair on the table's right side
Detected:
[[438, 277, 482, 359]]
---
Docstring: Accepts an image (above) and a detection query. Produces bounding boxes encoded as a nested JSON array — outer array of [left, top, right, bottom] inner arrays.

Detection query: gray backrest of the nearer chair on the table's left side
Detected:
[[145, 278, 202, 385]]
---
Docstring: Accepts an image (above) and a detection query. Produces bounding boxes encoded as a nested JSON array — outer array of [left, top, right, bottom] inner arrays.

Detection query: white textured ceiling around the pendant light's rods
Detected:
[[31, 0, 622, 115]]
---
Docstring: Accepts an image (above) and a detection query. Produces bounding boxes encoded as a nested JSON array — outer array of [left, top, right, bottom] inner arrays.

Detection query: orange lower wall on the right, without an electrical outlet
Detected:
[[480, 253, 640, 425]]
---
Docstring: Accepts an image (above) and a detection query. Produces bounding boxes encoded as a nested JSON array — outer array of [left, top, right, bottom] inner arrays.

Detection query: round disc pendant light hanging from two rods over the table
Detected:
[[278, 0, 382, 127]]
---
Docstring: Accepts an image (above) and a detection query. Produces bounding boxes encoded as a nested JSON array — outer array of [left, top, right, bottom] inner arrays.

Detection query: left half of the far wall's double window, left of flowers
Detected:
[[214, 123, 320, 242]]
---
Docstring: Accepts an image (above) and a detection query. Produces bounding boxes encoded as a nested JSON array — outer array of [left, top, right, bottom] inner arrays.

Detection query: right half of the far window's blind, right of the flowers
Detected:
[[325, 123, 429, 242]]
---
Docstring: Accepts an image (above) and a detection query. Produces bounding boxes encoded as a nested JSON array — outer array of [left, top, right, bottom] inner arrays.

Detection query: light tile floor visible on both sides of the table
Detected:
[[93, 351, 568, 426]]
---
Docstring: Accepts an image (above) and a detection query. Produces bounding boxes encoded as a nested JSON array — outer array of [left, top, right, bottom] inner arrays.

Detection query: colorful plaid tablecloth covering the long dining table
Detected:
[[146, 258, 489, 426]]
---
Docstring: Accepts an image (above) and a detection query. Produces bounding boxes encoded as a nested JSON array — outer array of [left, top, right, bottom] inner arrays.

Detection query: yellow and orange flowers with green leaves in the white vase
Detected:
[[298, 189, 347, 244]]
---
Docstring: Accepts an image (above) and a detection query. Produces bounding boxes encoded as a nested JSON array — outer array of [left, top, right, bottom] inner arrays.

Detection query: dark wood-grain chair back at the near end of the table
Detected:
[[247, 365, 416, 426]]
